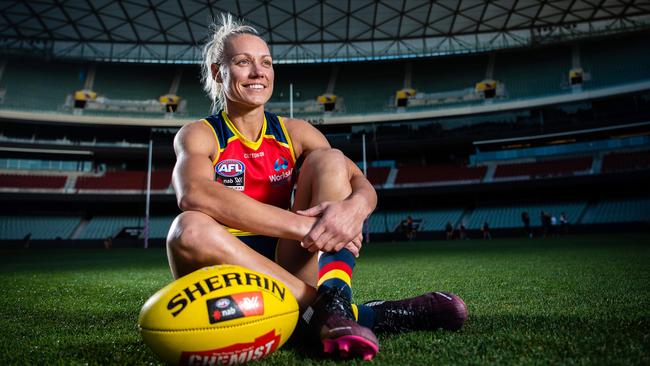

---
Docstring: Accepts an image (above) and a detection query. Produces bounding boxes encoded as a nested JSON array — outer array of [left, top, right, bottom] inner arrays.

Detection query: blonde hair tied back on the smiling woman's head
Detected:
[[201, 13, 258, 113]]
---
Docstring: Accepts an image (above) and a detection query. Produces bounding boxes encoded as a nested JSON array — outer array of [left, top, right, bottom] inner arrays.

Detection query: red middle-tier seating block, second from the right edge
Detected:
[[494, 156, 592, 178]]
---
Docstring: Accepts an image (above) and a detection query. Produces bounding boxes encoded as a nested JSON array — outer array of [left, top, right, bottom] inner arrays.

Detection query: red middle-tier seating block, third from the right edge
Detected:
[[395, 165, 487, 184]]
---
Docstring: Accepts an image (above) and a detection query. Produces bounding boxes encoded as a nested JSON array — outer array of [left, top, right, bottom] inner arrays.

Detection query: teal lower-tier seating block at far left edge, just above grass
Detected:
[[0, 215, 81, 240]]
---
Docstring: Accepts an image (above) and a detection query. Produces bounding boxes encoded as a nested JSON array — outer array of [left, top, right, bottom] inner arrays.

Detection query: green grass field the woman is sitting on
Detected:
[[0, 234, 650, 365]]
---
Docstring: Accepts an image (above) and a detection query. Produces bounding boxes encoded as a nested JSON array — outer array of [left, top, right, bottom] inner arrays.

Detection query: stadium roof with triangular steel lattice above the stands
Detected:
[[0, 0, 650, 63]]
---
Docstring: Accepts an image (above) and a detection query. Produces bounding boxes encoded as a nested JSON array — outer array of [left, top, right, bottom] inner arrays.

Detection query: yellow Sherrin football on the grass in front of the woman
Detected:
[[138, 265, 298, 365]]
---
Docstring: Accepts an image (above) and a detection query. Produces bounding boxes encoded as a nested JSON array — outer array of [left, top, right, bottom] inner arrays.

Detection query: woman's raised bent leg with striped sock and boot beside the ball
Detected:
[[276, 149, 379, 360]]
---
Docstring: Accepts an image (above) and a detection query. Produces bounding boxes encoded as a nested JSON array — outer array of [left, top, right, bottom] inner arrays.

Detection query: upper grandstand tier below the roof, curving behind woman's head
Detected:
[[0, 34, 650, 123]]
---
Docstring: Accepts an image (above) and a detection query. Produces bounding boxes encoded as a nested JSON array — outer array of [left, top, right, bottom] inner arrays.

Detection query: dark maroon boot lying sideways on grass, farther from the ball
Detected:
[[364, 292, 467, 333]]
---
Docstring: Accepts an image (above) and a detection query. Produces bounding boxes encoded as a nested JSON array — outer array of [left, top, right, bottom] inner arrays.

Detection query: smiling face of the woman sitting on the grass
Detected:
[[217, 34, 275, 107]]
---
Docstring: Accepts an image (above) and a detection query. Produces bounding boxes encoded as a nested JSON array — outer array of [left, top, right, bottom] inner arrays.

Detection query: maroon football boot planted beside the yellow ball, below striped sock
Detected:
[[303, 288, 379, 361]]
